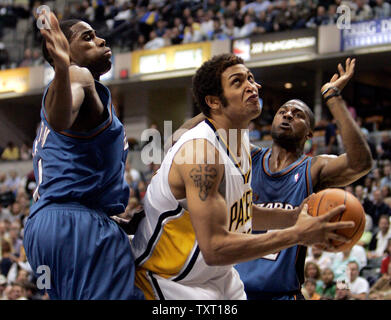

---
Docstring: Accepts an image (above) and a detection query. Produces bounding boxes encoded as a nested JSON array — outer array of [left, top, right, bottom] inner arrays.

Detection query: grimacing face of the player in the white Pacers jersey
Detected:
[[221, 64, 261, 127]]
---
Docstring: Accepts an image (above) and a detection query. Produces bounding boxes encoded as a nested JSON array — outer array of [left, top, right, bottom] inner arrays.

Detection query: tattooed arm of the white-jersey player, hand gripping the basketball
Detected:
[[175, 142, 353, 265]]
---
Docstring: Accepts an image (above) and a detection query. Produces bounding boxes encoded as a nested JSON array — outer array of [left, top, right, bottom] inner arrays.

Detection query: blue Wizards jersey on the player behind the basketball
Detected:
[[235, 148, 312, 299]]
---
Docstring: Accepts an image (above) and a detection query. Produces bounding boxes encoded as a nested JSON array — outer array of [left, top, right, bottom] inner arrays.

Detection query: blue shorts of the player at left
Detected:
[[23, 203, 144, 300]]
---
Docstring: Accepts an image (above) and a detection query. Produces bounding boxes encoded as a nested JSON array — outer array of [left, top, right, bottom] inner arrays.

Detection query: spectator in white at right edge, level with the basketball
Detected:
[[368, 215, 391, 259]]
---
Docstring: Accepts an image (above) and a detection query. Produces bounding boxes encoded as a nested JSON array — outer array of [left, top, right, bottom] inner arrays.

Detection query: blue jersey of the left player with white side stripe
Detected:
[[30, 81, 129, 217]]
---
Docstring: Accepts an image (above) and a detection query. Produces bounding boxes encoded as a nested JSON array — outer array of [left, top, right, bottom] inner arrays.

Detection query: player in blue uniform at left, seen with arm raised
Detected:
[[24, 13, 143, 299]]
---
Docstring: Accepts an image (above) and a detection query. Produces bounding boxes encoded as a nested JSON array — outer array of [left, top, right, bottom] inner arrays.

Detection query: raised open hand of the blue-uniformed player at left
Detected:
[[38, 10, 70, 68]]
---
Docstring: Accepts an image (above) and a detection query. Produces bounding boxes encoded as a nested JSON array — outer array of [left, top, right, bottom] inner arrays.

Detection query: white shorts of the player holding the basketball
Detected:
[[137, 268, 246, 300]]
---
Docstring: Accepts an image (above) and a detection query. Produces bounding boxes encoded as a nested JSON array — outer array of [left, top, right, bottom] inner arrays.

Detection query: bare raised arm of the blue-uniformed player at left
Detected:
[[40, 12, 94, 131]]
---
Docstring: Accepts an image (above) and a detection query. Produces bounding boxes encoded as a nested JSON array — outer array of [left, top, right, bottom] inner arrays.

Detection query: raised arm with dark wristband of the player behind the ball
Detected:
[[311, 58, 372, 191]]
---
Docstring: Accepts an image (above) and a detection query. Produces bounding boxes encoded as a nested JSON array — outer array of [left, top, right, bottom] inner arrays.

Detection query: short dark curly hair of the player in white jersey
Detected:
[[193, 53, 244, 117]]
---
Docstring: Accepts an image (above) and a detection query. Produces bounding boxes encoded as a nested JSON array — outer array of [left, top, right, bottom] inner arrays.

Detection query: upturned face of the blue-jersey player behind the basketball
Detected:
[[272, 100, 310, 146]]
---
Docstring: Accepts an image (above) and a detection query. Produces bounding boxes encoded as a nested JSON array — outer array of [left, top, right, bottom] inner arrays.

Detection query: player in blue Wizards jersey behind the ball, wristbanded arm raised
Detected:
[[236, 59, 372, 300]]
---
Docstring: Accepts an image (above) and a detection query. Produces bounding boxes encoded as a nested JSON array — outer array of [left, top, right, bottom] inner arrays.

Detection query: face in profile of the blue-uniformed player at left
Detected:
[[70, 22, 112, 75]]
